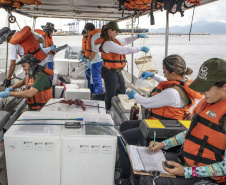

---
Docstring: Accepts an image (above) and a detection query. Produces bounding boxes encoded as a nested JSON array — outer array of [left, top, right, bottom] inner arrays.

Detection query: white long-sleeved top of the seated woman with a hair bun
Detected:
[[134, 74, 184, 108]]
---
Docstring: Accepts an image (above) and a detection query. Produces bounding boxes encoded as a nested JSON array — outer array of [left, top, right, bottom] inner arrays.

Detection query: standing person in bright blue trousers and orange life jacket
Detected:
[[84, 23, 103, 99]]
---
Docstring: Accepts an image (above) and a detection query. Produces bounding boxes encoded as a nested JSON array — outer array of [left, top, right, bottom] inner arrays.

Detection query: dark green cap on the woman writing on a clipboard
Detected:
[[189, 58, 226, 92]]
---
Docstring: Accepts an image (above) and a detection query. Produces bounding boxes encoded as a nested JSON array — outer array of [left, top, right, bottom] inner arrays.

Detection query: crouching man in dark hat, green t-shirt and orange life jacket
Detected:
[[0, 54, 53, 110]]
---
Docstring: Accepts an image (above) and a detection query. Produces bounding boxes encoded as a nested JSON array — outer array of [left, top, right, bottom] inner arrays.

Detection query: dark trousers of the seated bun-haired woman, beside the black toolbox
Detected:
[[118, 120, 141, 179]]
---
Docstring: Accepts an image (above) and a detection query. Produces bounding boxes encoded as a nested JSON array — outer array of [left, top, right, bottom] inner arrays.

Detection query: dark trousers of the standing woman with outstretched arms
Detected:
[[101, 66, 126, 110]]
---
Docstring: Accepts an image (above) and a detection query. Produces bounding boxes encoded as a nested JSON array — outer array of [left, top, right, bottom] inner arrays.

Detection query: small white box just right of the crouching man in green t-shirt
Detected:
[[54, 59, 69, 76]]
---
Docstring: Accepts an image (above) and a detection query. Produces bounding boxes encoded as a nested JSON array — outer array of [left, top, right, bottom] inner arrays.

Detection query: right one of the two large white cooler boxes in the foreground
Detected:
[[61, 122, 117, 185]]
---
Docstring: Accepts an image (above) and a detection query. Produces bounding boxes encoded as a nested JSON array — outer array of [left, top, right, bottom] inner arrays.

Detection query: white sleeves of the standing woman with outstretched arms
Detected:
[[102, 35, 140, 55]]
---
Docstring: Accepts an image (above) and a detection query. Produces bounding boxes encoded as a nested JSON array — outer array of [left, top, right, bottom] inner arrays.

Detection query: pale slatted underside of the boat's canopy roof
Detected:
[[8, 0, 217, 21]]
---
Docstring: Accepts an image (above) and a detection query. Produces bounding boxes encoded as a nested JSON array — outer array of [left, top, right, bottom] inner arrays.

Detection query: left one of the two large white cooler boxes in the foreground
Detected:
[[4, 111, 62, 185]]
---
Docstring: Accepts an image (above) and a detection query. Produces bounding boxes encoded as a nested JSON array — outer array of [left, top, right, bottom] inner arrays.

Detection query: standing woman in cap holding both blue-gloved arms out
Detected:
[[95, 21, 149, 112]]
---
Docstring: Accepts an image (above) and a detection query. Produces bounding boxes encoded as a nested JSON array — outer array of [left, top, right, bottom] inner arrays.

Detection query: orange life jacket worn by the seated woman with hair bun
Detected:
[[149, 81, 203, 120]]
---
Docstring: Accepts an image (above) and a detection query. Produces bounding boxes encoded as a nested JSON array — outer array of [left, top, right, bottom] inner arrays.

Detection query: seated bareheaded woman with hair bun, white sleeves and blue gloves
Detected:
[[116, 55, 202, 184]]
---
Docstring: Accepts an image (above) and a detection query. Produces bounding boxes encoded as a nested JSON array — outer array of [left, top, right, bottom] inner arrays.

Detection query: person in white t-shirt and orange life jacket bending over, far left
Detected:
[[0, 26, 47, 87]]
